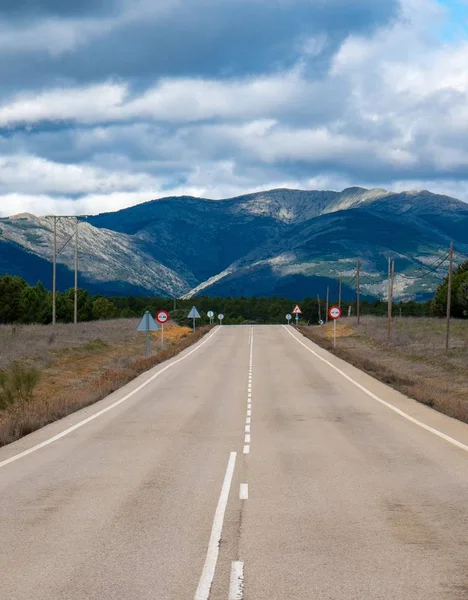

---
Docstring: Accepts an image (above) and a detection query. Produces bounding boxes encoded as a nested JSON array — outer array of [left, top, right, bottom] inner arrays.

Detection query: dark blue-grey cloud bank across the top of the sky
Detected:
[[0, 0, 398, 91]]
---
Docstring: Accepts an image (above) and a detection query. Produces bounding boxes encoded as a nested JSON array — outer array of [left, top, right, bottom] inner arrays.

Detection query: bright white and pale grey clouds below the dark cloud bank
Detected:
[[0, 0, 468, 214]]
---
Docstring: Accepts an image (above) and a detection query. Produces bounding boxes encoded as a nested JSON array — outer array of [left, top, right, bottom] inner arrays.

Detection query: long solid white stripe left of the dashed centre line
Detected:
[[195, 452, 237, 600]]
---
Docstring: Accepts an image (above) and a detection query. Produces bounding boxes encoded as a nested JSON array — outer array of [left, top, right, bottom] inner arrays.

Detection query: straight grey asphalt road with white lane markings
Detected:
[[0, 326, 468, 600]]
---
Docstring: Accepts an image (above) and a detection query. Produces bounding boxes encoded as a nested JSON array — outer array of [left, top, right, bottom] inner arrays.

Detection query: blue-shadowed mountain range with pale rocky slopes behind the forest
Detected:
[[0, 187, 468, 300]]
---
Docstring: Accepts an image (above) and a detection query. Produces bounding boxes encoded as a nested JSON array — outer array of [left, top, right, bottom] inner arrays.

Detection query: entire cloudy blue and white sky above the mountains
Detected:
[[0, 0, 468, 215]]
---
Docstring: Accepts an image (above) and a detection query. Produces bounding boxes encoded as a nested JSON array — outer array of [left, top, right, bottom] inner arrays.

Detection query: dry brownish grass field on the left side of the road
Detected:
[[0, 319, 208, 446]]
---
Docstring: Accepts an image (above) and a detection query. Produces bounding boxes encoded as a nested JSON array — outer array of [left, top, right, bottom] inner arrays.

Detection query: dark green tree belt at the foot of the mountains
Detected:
[[0, 274, 436, 324]]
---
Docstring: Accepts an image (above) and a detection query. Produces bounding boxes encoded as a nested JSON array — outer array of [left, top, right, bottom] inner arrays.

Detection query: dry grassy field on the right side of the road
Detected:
[[300, 317, 468, 423]]
